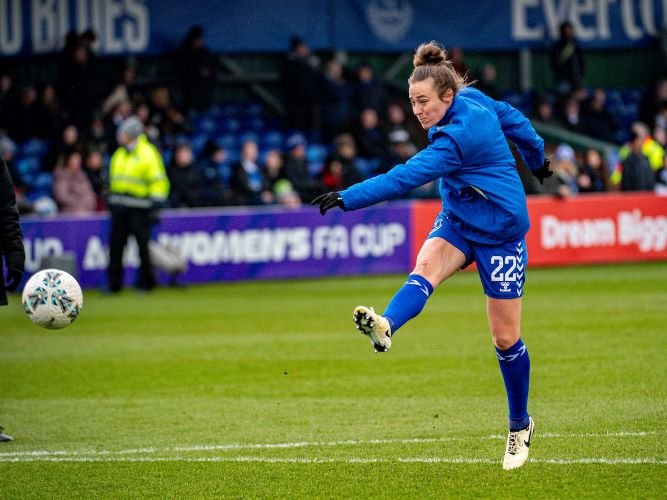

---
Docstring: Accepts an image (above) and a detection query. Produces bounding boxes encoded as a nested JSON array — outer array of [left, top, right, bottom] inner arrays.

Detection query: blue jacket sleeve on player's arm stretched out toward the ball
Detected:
[[339, 133, 462, 211]]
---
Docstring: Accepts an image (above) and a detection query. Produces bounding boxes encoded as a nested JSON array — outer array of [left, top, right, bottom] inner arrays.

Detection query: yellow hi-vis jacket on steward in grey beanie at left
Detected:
[[109, 134, 169, 208]]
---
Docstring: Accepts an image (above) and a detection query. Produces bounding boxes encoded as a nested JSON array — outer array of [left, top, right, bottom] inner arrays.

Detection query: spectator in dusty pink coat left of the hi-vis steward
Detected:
[[53, 151, 97, 213]]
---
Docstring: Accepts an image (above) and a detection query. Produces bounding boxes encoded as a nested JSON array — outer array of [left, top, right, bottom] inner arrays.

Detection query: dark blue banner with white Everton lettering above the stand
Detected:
[[0, 0, 667, 56]]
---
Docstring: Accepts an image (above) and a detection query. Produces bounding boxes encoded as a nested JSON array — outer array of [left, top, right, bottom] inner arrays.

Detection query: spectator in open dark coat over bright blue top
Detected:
[[231, 140, 275, 205]]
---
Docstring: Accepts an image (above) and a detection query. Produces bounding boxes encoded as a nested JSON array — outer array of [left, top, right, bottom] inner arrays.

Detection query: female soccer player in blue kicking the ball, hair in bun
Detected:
[[312, 42, 552, 469]]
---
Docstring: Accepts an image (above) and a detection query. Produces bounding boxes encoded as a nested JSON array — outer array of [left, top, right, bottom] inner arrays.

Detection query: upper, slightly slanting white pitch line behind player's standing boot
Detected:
[[0, 431, 665, 461]]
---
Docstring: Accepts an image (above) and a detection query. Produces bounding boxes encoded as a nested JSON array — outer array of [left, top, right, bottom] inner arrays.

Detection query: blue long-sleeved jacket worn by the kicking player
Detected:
[[340, 87, 544, 245]]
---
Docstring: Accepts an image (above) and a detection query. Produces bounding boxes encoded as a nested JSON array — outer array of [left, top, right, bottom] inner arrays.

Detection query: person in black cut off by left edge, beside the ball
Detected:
[[0, 155, 25, 443]]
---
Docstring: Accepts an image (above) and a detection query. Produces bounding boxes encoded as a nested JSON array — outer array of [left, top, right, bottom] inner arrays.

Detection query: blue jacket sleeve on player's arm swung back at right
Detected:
[[488, 98, 544, 170]]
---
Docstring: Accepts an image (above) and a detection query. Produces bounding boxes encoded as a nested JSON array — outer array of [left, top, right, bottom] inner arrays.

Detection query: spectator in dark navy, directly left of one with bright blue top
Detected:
[[197, 141, 232, 207]]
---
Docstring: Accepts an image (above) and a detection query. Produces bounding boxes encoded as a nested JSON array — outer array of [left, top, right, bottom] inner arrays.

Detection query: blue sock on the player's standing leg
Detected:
[[496, 339, 530, 431]]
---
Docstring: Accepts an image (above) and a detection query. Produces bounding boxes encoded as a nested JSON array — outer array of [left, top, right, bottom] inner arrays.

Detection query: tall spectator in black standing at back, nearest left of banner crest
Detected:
[[280, 37, 320, 132]]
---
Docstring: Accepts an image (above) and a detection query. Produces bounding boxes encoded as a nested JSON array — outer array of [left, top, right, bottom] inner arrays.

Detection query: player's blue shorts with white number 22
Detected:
[[428, 214, 528, 299]]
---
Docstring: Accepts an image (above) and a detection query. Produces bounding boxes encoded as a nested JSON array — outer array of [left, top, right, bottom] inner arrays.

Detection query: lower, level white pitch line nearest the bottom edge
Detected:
[[0, 456, 667, 465]]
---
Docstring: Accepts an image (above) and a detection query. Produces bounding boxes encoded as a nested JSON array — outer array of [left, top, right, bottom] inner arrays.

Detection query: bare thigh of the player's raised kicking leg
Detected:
[[412, 237, 466, 288]]
